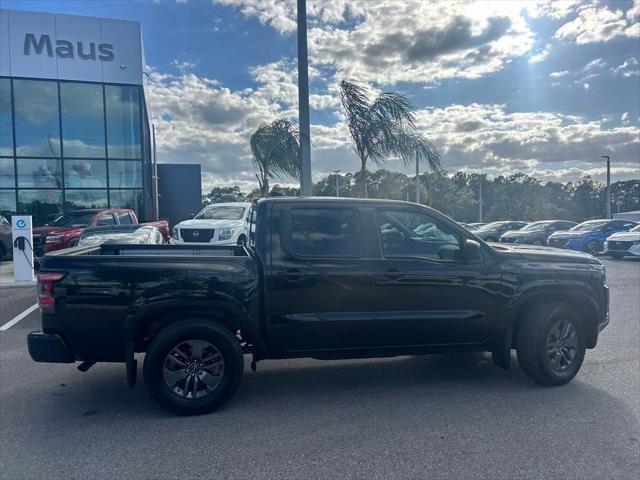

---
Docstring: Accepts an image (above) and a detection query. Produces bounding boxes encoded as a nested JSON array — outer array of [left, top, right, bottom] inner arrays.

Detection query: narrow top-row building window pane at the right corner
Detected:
[[105, 85, 141, 158]]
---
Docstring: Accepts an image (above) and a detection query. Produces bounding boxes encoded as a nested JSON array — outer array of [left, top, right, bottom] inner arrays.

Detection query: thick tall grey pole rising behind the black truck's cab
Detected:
[[298, 0, 311, 196]]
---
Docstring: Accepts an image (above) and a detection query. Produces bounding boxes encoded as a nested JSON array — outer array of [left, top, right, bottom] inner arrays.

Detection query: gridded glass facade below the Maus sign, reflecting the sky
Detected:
[[0, 77, 151, 225]]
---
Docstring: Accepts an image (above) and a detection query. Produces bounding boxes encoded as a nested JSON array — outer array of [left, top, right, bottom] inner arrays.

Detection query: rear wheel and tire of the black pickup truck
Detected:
[[143, 319, 244, 415]]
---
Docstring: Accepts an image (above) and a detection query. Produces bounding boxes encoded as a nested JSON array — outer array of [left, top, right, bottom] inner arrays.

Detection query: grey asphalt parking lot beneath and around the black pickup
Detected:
[[0, 259, 640, 479]]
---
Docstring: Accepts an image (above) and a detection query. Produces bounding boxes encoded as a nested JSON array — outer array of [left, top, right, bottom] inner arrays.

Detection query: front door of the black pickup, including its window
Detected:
[[372, 208, 500, 346]]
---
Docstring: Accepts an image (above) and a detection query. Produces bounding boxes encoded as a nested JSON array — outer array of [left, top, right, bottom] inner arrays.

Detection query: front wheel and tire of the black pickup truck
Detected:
[[516, 303, 585, 386]]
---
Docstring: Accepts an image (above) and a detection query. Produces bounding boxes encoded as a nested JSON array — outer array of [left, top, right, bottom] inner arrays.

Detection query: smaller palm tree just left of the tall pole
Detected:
[[251, 119, 300, 197]]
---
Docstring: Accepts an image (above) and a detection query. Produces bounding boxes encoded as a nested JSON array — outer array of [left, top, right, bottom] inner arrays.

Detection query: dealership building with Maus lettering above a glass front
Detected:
[[0, 10, 156, 225]]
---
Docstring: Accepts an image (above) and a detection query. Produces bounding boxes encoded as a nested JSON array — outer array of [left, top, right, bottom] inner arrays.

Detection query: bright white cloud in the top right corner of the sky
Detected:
[[554, 2, 640, 45]]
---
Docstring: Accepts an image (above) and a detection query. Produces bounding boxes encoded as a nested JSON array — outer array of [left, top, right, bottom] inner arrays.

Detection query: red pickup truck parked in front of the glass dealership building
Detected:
[[33, 208, 169, 256]]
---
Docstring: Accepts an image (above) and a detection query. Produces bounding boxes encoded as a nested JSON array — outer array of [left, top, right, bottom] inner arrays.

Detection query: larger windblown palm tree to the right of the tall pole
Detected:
[[340, 80, 440, 198]]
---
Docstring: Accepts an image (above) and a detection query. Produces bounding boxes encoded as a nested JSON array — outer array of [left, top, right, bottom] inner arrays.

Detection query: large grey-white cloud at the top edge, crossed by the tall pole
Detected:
[[218, 0, 533, 85]]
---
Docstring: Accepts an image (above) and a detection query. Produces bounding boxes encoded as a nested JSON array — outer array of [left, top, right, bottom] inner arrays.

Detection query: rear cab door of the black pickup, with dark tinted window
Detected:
[[266, 202, 380, 352]]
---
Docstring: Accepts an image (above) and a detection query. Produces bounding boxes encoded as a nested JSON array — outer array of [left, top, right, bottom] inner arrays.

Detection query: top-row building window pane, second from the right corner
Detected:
[[60, 82, 105, 158]]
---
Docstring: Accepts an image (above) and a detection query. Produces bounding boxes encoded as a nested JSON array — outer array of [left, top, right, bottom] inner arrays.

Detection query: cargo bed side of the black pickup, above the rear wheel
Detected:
[[39, 244, 259, 361]]
